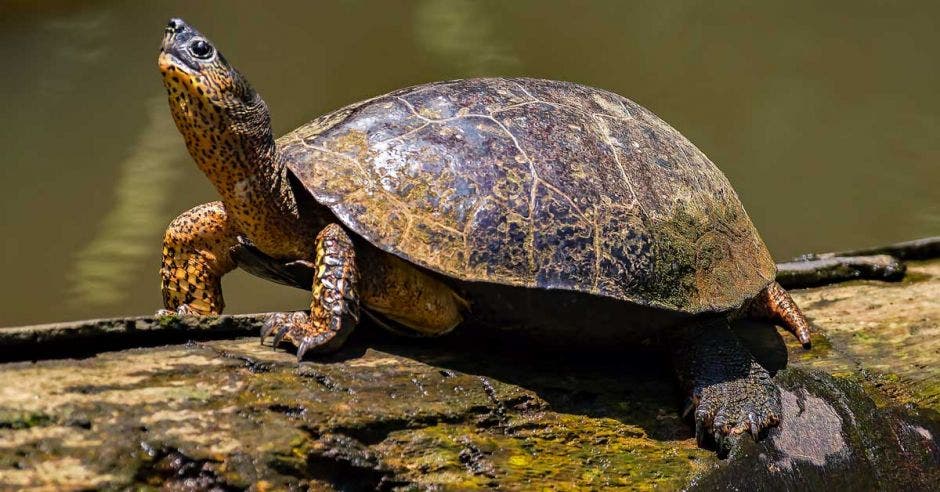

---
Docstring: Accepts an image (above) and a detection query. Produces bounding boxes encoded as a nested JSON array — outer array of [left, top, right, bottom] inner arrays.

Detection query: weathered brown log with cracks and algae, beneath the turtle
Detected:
[[0, 261, 940, 490]]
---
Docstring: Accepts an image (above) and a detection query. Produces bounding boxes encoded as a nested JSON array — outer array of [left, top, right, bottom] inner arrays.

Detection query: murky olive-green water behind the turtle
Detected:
[[0, 0, 940, 325]]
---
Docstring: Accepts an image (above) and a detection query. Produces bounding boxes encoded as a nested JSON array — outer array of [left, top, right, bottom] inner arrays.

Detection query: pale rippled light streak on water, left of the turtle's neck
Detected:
[[67, 96, 185, 307]]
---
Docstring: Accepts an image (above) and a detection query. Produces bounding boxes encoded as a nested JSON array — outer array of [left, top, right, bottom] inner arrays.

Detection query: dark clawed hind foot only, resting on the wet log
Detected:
[[685, 363, 782, 454]]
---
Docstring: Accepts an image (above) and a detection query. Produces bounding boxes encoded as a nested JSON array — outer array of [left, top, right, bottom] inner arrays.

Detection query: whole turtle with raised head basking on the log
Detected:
[[158, 19, 810, 450]]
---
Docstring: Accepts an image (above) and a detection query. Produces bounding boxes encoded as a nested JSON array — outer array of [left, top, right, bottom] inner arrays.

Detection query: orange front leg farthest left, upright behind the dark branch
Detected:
[[158, 202, 238, 315]]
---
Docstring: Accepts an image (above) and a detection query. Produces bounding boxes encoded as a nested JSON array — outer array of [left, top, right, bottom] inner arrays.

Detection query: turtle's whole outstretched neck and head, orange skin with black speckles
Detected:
[[158, 18, 316, 259]]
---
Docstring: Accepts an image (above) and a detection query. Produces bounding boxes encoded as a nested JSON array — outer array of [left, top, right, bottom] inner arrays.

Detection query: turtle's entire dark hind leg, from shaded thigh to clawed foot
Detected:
[[672, 319, 782, 452]]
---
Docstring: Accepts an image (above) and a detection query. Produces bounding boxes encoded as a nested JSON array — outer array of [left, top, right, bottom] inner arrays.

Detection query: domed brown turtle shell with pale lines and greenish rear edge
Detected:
[[278, 78, 776, 313]]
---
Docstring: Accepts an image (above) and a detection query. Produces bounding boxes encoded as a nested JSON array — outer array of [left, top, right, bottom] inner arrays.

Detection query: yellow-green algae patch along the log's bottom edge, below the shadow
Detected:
[[377, 413, 716, 489]]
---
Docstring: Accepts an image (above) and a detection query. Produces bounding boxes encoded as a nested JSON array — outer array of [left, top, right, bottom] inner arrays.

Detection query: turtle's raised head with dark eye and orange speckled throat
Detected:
[[158, 19, 274, 180]]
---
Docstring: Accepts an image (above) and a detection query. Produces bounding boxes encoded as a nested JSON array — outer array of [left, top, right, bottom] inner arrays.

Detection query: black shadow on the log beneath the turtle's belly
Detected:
[[360, 326, 692, 441]]
